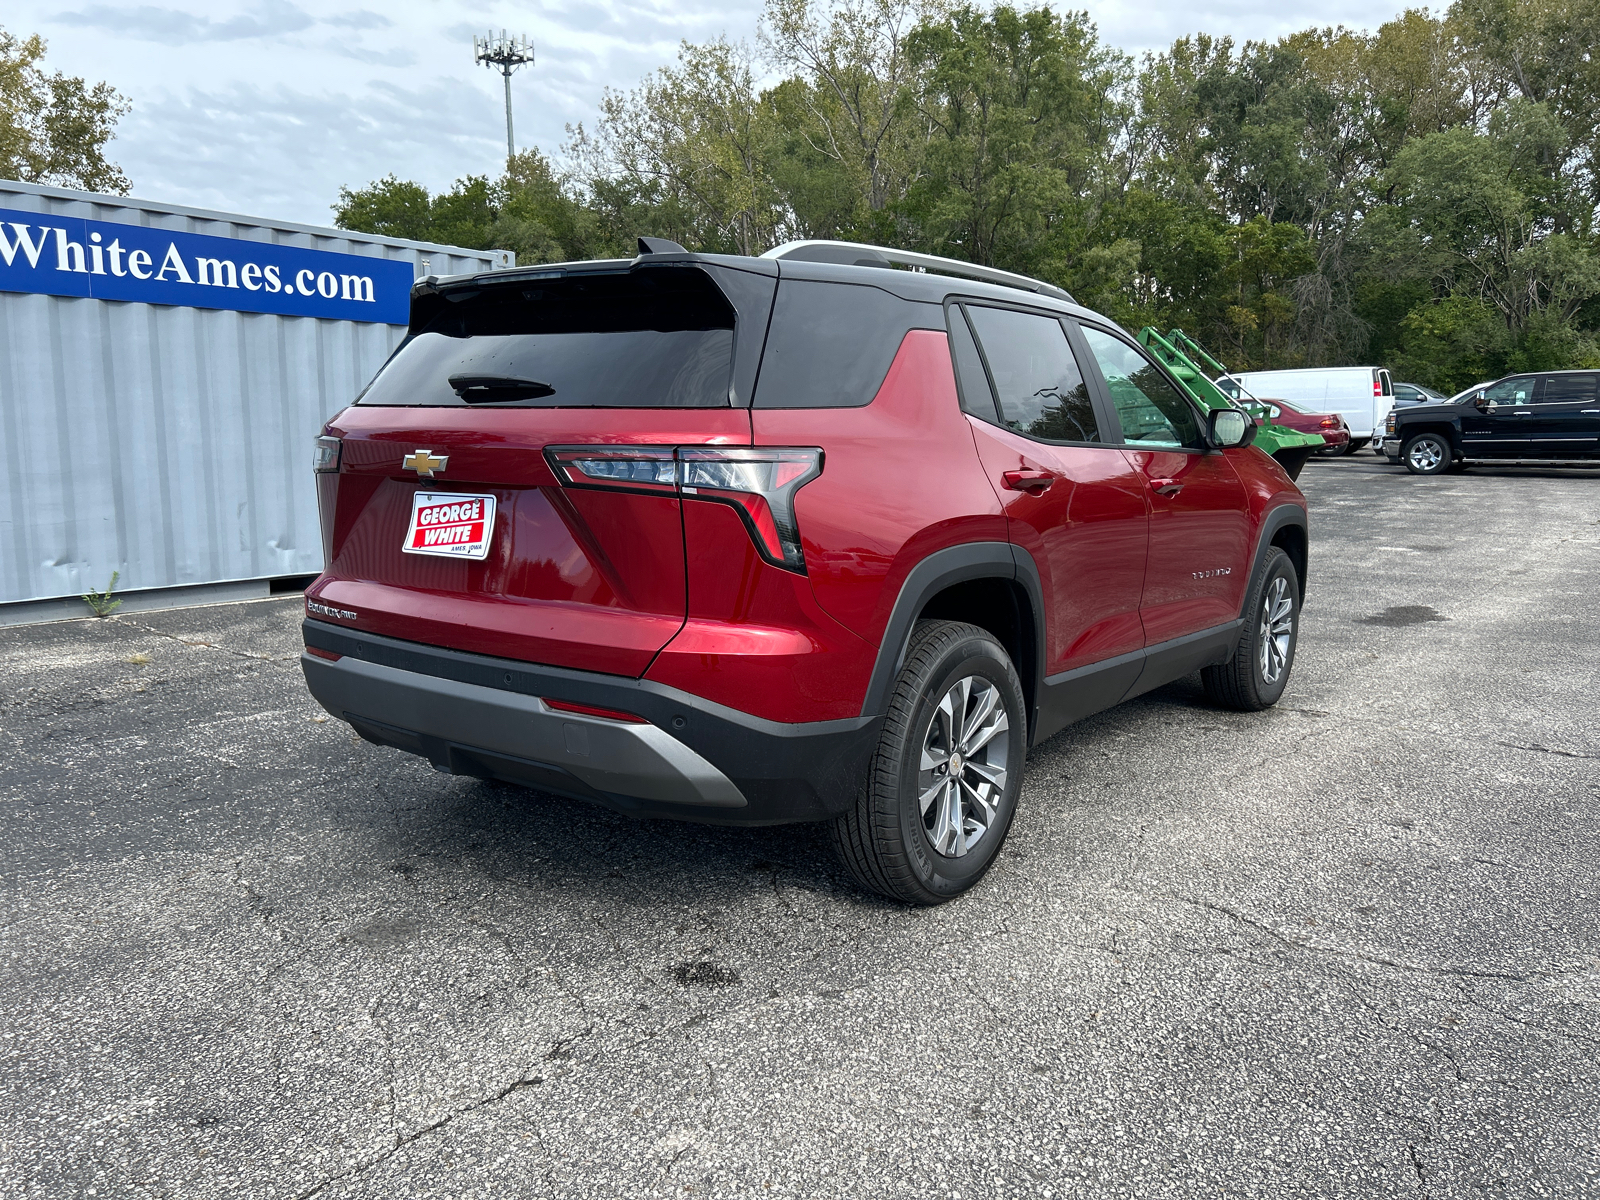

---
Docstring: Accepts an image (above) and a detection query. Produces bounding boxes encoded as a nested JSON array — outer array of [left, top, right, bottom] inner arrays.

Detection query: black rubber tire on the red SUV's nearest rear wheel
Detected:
[[834, 621, 1027, 904]]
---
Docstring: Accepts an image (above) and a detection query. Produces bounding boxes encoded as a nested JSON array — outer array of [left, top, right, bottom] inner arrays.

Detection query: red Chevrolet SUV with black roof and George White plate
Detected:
[[301, 238, 1307, 904]]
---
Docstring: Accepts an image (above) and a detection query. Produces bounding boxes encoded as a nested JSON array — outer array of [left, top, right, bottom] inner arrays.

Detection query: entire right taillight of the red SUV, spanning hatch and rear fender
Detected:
[[544, 446, 822, 574]]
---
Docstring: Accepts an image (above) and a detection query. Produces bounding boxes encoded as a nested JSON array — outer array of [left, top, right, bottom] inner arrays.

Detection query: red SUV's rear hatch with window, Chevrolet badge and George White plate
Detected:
[[307, 254, 774, 675]]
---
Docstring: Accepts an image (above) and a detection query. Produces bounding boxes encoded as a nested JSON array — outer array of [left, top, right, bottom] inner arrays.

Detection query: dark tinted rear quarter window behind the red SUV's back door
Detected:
[[755, 278, 944, 408]]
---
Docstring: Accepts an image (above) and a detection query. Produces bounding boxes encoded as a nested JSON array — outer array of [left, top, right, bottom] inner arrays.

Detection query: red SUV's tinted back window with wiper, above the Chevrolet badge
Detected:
[[357, 267, 734, 408]]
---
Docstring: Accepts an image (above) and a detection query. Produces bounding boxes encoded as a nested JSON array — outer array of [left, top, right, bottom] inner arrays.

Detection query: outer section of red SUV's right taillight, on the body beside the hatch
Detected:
[[678, 446, 822, 574]]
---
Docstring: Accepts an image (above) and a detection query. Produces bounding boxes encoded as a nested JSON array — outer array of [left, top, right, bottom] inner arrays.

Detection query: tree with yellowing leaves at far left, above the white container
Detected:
[[0, 29, 130, 195]]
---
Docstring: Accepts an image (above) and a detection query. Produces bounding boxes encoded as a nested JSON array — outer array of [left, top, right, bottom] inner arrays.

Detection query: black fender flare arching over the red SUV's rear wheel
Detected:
[[861, 542, 1045, 726]]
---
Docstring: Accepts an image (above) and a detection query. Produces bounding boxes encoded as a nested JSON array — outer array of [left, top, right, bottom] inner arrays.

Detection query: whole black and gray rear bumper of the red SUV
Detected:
[[301, 621, 880, 826]]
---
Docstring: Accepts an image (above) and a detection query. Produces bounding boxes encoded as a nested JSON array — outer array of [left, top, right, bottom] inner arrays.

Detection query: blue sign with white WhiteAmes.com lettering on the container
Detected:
[[0, 208, 416, 325]]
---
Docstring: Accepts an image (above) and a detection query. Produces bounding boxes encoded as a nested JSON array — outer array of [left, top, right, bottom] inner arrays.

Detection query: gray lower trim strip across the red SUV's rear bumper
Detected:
[[301, 654, 749, 808]]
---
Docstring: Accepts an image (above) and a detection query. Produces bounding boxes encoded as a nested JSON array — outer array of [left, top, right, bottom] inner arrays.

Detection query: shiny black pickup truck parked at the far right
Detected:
[[1382, 371, 1600, 475]]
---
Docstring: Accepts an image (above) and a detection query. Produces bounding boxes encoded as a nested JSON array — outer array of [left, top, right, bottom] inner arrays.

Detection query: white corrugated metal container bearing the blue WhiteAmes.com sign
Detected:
[[0, 181, 514, 626]]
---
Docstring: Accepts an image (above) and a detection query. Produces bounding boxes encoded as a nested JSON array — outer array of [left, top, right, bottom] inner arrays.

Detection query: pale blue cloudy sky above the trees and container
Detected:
[[15, 0, 1400, 224]]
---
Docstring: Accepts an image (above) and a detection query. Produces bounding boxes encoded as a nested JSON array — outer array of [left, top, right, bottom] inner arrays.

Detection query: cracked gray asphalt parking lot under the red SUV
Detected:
[[0, 454, 1600, 1200]]
